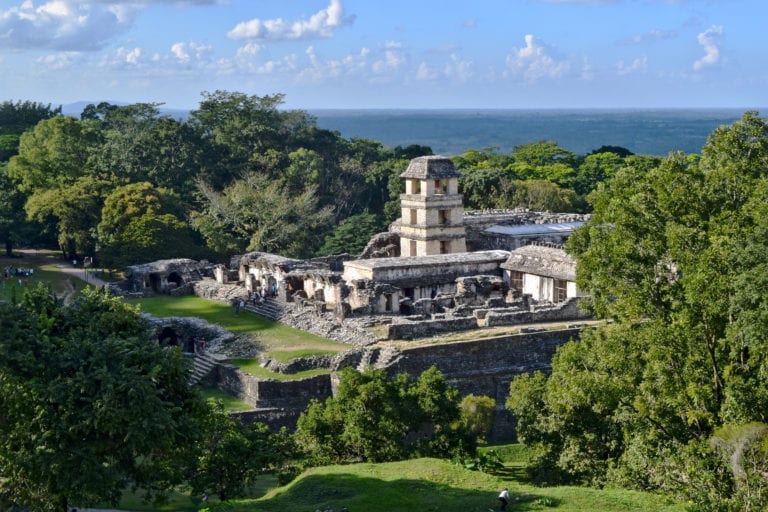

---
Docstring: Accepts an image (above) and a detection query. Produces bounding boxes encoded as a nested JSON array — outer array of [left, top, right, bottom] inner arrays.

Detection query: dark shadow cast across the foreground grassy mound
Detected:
[[240, 474, 556, 512]]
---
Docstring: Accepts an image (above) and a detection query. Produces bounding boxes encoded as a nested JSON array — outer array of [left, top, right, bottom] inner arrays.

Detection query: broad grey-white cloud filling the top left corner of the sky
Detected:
[[0, 0, 131, 51]]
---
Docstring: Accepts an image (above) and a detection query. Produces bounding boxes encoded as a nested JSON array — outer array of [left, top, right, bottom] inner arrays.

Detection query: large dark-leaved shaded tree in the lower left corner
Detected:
[[0, 285, 205, 512]]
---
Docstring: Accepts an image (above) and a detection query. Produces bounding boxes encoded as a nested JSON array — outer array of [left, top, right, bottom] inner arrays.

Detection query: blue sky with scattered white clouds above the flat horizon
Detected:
[[0, 0, 768, 109]]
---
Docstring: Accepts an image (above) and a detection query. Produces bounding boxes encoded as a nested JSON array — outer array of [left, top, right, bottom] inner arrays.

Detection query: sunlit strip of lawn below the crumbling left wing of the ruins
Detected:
[[129, 295, 349, 360]]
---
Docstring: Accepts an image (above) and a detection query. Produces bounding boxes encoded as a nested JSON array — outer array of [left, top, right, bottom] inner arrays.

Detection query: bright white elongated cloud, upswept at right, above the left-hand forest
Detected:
[[227, 0, 354, 41]]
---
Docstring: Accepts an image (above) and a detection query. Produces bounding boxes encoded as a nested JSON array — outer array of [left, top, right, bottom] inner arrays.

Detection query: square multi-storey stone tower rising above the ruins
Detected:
[[400, 156, 467, 256]]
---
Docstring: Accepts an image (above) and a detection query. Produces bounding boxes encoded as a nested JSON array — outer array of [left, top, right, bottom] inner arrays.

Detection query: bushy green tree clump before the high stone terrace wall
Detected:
[[296, 368, 475, 464]]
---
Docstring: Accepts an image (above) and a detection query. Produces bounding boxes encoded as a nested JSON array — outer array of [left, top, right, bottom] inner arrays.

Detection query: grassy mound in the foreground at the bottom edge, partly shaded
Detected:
[[224, 459, 685, 512]]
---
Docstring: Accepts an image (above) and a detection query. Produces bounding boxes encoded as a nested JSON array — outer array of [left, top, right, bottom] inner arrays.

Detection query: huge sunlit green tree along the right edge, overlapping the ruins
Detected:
[[509, 112, 768, 510]]
